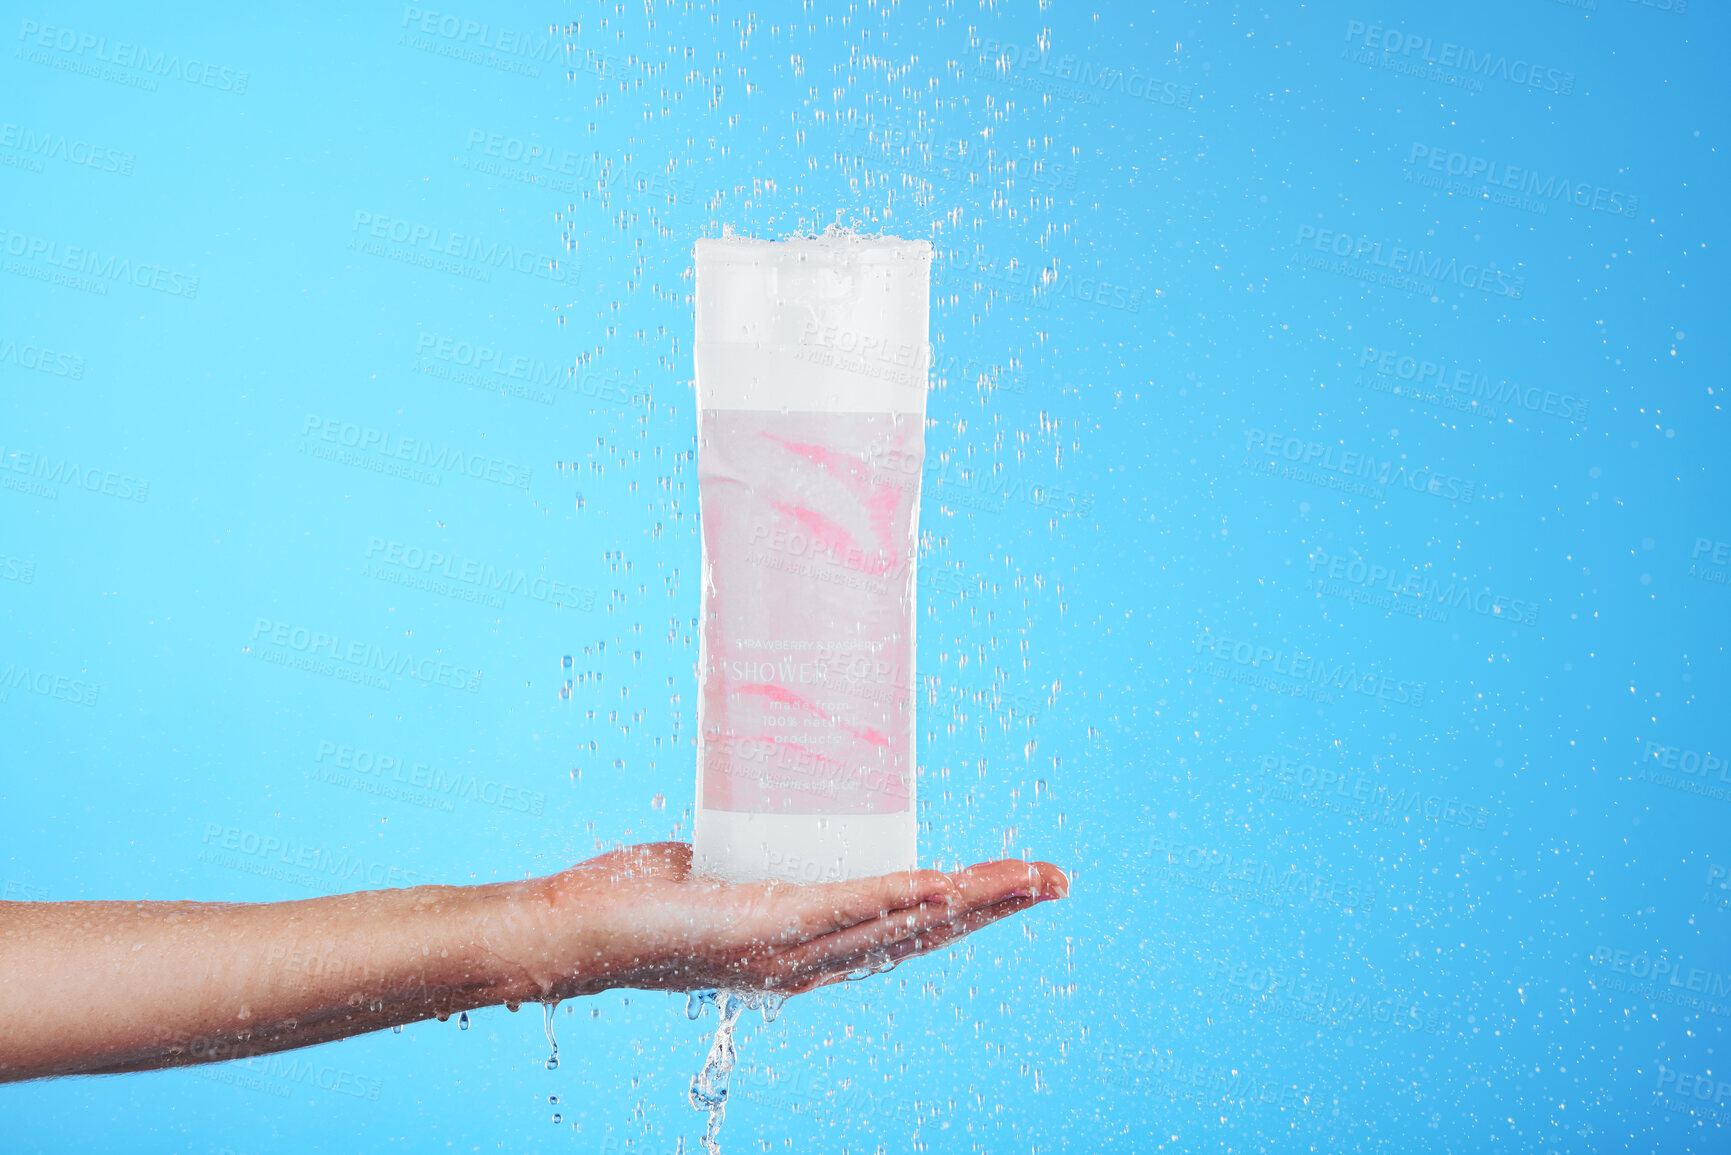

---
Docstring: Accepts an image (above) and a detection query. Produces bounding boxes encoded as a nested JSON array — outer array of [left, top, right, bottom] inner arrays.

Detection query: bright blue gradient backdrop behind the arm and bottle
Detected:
[[0, 0, 1731, 1155]]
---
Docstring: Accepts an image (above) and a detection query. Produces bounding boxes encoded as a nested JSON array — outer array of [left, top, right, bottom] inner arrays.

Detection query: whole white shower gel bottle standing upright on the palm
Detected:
[[694, 234, 931, 881]]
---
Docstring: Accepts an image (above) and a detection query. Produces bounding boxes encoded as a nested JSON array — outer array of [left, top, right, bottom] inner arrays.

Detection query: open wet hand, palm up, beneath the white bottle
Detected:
[[523, 842, 1070, 997]]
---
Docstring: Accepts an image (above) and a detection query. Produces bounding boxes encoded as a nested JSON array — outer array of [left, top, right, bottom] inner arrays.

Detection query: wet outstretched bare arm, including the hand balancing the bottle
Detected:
[[0, 842, 1068, 1082]]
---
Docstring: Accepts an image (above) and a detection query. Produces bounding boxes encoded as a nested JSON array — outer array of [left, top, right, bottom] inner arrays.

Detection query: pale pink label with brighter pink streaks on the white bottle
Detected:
[[698, 409, 924, 814]]
